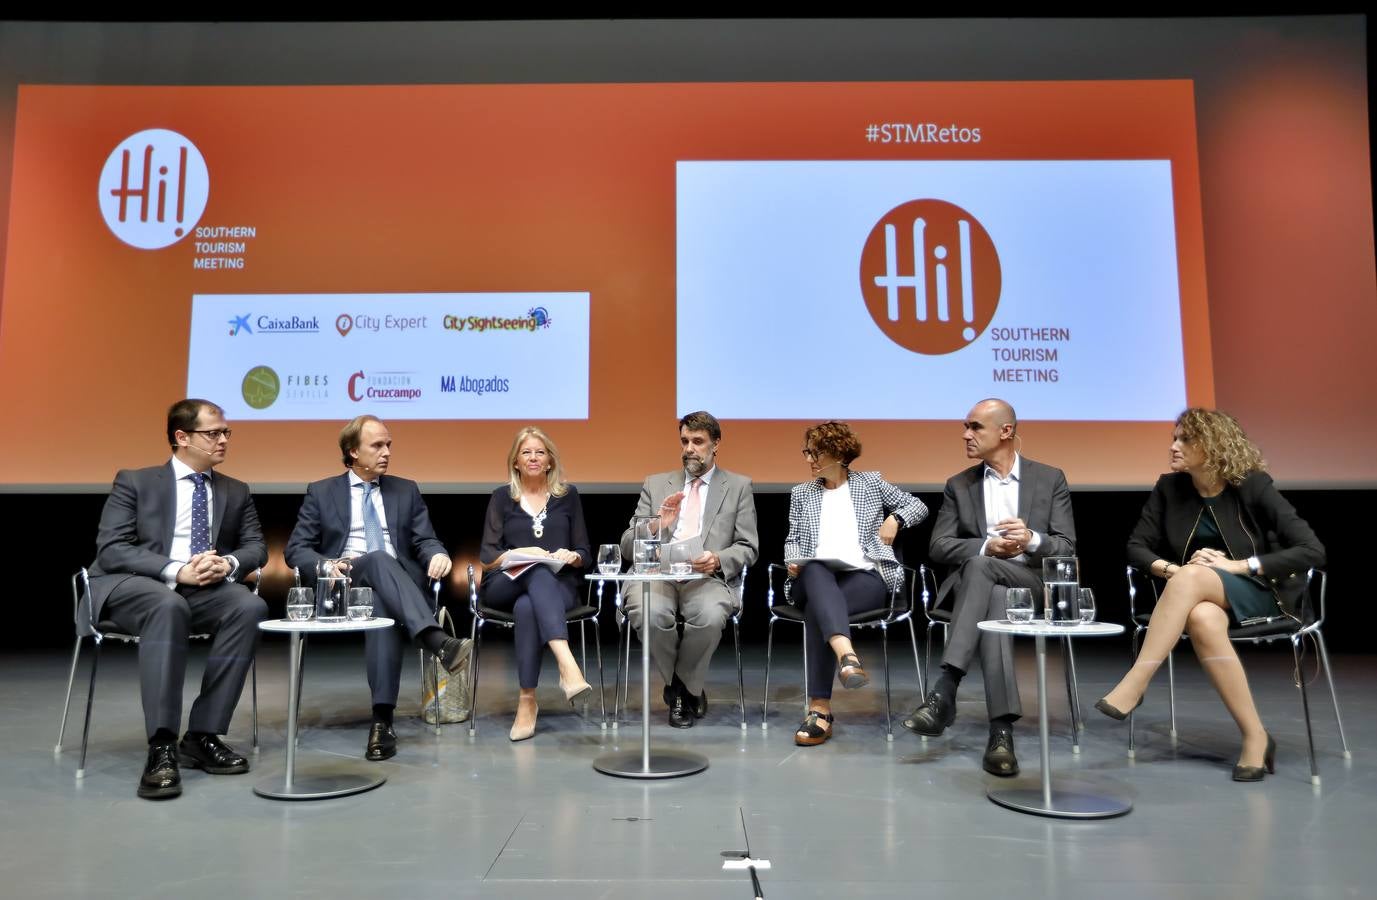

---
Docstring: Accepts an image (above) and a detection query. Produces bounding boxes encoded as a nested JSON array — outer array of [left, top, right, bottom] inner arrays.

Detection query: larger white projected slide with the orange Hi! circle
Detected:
[[676, 160, 1186, 421]]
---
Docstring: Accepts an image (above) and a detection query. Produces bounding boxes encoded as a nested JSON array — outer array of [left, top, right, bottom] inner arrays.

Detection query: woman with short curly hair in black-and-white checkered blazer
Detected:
[[784, 421, 928, 746]]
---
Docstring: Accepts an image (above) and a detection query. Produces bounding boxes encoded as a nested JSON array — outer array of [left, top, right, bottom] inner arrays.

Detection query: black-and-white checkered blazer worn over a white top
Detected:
[[784, 472, 928, 590]]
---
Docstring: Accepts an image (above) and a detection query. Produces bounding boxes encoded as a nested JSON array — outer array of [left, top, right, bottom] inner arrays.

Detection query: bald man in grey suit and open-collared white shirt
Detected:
[[903, 399, 1075, 776]]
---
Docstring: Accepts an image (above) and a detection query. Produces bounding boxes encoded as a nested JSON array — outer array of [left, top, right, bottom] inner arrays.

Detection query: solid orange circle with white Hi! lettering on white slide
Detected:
[[861, 200, 1001, 355]]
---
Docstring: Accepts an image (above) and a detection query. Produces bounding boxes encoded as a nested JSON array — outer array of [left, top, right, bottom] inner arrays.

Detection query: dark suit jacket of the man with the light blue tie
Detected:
[[286, 472, 445, 590]]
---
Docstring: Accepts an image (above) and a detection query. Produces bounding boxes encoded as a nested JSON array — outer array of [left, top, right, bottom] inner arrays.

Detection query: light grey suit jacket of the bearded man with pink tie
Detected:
[[621, 465, 760, 586]]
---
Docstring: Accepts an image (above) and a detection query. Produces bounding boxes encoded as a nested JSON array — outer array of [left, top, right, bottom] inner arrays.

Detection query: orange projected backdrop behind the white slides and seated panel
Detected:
[[0, 81, 1213, 486]]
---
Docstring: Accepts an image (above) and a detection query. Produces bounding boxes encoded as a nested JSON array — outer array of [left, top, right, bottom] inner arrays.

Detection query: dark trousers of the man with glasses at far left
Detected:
[[101, 575, 267, 738]]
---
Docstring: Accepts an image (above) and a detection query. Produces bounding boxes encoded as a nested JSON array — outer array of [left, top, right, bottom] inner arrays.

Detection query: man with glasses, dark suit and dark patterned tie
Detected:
[[90, 399, 267, 800]]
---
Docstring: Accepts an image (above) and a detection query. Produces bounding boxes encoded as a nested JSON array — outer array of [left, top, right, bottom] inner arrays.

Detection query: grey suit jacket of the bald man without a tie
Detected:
[[928, 456, 1075, 603]]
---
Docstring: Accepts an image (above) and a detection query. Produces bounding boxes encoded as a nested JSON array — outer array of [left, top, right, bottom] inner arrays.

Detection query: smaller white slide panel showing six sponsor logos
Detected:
[[186, 292, 589, 420]]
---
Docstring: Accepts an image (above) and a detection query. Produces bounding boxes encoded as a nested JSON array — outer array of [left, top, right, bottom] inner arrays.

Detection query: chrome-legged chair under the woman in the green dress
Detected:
[[1126, 566, 1352, 784]]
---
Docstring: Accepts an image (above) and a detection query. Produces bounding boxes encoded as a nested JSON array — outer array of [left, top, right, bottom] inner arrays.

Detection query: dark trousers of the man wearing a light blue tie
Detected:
[[350, 550, 439, 706]]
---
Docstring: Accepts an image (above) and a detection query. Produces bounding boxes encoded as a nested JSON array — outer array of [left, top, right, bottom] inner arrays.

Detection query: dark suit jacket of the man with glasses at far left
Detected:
[[91, 462, 267, 614]]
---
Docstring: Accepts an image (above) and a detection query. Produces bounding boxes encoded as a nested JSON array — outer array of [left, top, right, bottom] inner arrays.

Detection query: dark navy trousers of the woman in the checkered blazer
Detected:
[[789, 563, 888, 699]]
